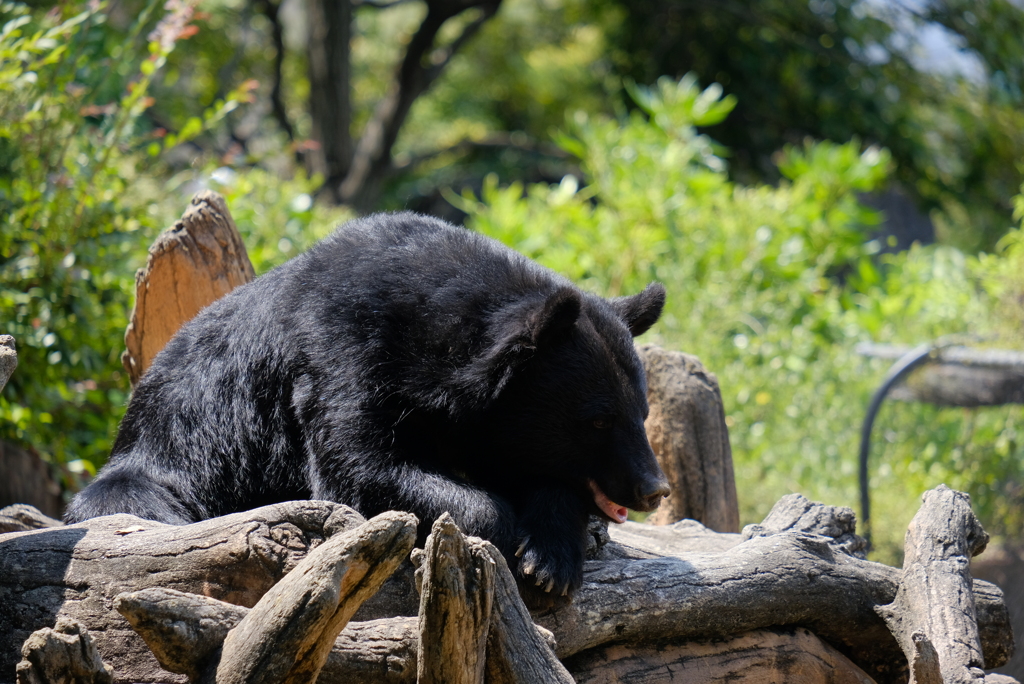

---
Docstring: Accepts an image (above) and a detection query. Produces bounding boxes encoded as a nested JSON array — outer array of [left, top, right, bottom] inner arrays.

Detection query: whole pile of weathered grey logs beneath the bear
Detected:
[[0, 486, 1014, 684]]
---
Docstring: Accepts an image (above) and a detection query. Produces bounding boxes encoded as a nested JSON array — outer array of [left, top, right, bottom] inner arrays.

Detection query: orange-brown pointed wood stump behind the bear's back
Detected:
[[121, 190, 255, 387]]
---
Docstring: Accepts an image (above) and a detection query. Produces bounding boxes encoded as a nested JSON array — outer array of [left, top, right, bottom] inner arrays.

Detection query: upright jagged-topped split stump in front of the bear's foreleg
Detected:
[[416, 513, 495, 684]]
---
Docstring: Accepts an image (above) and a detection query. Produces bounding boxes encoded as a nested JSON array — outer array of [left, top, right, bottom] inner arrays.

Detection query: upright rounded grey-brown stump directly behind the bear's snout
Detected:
[[638, 344, 739, 532]]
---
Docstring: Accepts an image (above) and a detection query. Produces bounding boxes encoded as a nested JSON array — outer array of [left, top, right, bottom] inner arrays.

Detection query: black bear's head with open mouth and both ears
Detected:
[[466, 283, 669, 522]]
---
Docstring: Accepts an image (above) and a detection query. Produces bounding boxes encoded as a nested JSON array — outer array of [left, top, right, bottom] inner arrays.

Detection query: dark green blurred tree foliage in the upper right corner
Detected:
[[608, 0, 1024, 249]]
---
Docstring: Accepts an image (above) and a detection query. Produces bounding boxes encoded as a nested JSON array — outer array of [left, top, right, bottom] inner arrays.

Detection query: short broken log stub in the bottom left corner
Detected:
[[17, 617, 114, 684]]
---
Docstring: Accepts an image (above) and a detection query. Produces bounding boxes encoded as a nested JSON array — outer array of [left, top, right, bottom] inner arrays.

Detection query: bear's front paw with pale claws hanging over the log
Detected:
[[515, 537, 583, 610]]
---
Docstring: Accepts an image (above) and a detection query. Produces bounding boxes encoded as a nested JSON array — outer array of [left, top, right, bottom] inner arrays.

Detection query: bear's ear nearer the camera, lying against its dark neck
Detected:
[[459, 287, 583, 403]]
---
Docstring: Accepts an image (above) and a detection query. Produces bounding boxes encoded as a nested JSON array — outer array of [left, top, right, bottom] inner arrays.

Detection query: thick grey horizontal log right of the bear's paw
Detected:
[[539, 497, 1013, 681]]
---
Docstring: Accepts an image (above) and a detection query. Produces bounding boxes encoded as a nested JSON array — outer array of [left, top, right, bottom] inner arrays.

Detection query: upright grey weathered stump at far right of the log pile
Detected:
[[877, 485, 988, 684]]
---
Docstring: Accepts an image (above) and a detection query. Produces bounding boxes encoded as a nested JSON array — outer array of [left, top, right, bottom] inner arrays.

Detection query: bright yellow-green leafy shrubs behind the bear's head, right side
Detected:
[[462, 77, 1024, 560]]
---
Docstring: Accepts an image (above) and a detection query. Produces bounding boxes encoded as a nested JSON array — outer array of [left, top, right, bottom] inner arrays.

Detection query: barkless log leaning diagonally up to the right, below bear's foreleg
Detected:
[[214, 511, 419, 684]]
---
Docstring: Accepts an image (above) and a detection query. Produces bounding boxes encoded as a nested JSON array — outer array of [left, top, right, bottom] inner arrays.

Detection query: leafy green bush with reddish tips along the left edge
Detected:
[[0, 3, 253, 484]]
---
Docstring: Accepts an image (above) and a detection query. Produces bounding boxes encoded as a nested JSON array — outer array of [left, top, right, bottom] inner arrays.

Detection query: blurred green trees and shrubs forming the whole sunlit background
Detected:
[[0, 0, 1024, 563]]
